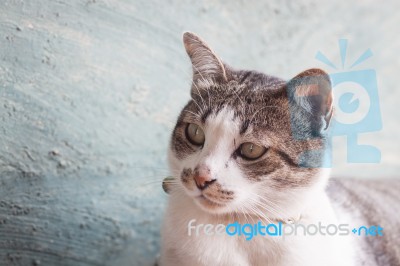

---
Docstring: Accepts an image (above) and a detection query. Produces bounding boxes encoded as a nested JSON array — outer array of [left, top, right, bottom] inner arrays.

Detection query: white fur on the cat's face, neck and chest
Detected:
[[160, 109, 354, 266]]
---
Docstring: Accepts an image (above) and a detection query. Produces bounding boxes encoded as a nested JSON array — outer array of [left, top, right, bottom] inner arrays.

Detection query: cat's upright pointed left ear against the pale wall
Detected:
[[183, 32, 227, 82]]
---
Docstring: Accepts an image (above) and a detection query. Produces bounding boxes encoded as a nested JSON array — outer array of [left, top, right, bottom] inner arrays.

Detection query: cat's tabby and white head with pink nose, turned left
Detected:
[[169, 32, 332, 218]]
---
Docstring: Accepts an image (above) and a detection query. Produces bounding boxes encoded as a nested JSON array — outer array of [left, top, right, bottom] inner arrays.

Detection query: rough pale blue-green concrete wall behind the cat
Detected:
[[0, 0, 400, 265]]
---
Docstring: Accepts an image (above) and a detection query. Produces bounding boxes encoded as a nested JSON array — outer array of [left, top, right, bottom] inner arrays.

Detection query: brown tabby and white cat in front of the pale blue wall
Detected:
[[159, 32, 400, 266]]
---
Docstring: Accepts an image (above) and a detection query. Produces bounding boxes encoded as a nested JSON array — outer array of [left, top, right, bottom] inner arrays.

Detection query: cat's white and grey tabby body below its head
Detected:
[[161, 179, 400, 266]]
